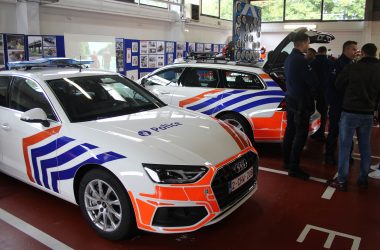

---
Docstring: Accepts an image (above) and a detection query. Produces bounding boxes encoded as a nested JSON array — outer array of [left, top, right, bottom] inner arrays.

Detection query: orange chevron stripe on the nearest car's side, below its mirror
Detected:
[[22, 126, 61, 182]]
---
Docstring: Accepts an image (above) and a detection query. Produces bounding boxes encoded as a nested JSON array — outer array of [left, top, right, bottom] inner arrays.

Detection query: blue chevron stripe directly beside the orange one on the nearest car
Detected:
[[30, 136, 75, 185]]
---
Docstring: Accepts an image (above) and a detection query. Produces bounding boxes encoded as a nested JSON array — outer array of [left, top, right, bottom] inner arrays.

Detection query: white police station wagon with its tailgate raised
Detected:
[[139, 29, 334, 142]]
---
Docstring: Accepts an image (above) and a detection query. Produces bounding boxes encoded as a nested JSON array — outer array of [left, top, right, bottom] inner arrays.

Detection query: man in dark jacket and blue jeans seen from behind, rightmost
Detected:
[[329, 43, 380, 191]]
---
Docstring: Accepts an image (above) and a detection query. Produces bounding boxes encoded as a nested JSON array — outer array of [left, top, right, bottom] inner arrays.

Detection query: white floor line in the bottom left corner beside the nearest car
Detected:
[[0, 208, 73, 250]]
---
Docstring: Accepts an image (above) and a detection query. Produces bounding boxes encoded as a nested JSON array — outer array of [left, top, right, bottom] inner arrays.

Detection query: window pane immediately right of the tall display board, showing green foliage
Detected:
[[251, 0, 284, 22]]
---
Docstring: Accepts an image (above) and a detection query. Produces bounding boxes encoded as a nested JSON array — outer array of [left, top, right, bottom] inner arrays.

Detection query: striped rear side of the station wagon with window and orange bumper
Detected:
[[220, 70, 284, 141]]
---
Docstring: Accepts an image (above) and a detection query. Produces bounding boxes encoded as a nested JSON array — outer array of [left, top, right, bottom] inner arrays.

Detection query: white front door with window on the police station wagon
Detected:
[[142, 67, 184, 104]]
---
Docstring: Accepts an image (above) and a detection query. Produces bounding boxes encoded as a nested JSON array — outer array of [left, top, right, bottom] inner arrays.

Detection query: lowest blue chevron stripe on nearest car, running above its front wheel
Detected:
[[51, 152, 127, 193]]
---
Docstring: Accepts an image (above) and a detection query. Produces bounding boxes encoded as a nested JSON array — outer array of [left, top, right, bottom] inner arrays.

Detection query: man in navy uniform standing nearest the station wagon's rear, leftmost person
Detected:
[[283, 32, 317, 180]]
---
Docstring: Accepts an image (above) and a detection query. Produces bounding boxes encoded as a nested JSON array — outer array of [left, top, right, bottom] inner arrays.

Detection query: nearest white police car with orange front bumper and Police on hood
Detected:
[[0, 59, 258, 240]]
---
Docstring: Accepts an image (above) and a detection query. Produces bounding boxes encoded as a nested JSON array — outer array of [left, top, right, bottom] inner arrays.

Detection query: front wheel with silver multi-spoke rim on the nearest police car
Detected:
[[78, 169, 136, 240]]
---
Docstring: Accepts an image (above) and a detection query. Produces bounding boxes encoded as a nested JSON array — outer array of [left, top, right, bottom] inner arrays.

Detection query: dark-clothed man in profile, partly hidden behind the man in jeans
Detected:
[[325, 41, 358, 165]]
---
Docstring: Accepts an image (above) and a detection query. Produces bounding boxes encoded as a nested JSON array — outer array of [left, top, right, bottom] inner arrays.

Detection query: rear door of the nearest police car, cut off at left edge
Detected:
[[0, 76, 12, 166]]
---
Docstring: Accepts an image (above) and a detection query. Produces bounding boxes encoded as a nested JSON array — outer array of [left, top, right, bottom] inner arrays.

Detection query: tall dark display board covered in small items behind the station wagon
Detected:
[[232, 0, 261, 63]]
